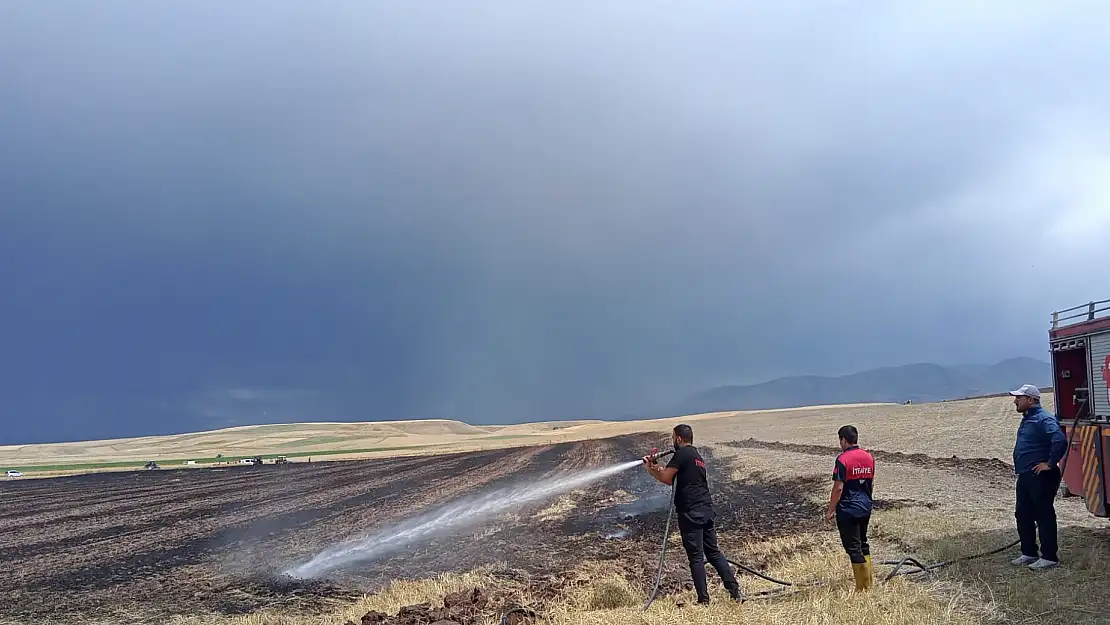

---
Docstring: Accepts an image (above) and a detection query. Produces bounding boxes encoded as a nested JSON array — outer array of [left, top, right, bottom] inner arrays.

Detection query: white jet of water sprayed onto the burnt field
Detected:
[[285, 460, 640, 579]]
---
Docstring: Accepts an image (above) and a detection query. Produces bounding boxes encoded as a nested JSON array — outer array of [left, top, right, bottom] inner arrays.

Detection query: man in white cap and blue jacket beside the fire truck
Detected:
[[1010, 384, 1068, 571]]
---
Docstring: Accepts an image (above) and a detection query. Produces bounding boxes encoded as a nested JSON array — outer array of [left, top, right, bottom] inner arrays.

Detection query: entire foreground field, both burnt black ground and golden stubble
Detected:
[[0, 397, 1110, 625]]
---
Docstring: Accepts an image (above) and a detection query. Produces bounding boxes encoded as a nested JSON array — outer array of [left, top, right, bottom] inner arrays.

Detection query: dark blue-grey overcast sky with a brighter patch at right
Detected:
[[0, 0, 1110, 439]]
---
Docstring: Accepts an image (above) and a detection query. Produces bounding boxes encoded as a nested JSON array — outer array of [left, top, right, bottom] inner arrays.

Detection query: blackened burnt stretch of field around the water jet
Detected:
[[0, 435, 818, 623]]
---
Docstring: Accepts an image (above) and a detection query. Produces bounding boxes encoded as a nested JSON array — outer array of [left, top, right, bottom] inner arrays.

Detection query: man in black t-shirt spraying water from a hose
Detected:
[[644, 425, 744, 604]]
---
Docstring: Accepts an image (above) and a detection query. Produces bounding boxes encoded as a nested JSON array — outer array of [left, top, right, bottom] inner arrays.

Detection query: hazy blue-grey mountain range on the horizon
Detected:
[[670, 357, 1052, 414]]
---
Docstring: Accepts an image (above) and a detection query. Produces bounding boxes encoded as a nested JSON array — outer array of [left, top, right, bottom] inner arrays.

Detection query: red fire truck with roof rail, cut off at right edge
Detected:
[[1048, 300, 1110, 517]]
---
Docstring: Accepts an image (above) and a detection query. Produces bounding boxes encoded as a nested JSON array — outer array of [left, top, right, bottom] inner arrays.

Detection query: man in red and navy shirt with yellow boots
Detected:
[[825, 425, 875, 591]]
